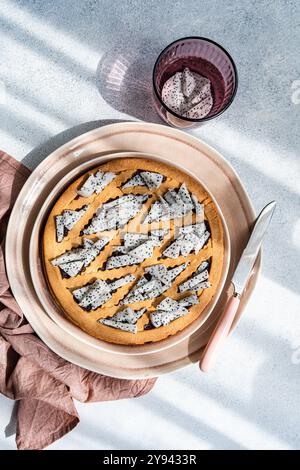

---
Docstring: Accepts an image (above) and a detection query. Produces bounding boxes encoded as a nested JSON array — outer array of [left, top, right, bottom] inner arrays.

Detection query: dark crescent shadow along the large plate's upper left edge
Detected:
[[22, 119, 127, 169]]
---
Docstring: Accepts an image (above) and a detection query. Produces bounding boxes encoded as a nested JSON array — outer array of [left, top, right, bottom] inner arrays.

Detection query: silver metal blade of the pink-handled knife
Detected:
[[231, 201, 276, 295]]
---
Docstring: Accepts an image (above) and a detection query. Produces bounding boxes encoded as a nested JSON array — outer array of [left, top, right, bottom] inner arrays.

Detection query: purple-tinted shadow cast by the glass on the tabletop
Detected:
[[96, 41, 162, 123]]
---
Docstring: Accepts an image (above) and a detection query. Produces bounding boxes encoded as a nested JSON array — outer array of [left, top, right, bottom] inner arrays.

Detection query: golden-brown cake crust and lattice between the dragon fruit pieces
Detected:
[[43, 158, 224, 345]]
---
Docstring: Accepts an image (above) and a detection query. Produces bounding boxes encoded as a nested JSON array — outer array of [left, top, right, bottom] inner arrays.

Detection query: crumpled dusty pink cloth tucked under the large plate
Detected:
[[0, 152, 156, 449]]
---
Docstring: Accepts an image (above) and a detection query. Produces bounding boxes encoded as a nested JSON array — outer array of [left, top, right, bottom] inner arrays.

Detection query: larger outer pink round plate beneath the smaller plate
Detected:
[[6, 123, 260, 378]]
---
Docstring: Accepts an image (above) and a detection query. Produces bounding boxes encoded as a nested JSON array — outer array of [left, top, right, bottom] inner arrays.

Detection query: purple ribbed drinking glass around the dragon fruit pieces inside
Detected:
[[153, 36, 238, 127]]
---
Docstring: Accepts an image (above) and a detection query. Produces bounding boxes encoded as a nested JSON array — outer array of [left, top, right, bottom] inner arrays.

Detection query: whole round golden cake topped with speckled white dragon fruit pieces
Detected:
[[43, 158, 224, 345]]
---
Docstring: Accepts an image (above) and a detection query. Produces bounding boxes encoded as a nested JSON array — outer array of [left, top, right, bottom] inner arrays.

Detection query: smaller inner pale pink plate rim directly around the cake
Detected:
[[29, 152, 230, 355]]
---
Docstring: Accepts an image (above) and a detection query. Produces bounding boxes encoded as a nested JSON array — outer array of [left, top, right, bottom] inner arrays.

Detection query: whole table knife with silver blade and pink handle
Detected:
[[200, 201, 276, 372]]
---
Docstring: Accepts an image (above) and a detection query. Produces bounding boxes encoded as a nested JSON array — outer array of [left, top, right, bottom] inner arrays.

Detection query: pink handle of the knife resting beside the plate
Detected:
[[200, 296, 240, 372]]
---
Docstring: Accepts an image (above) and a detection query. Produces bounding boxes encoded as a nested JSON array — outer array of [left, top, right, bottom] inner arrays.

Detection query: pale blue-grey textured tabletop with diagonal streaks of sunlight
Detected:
[[0, 0, 300, 449]]
